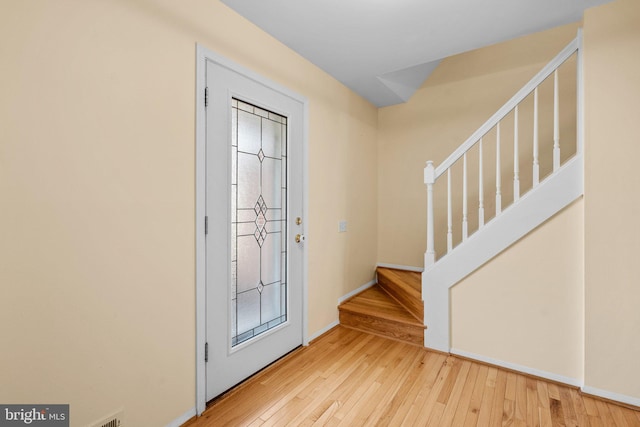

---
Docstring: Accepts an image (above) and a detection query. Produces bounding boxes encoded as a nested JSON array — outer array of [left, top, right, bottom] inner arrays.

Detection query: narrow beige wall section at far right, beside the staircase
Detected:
[[584, 0, 640, 401]]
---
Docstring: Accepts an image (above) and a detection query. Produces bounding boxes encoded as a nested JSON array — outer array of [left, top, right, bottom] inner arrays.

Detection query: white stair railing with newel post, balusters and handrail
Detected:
[[424, 33, 582, 270]]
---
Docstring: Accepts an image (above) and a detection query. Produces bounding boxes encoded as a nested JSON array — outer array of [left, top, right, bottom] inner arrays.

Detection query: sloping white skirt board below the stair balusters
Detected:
[[422, 154, 583, 352]]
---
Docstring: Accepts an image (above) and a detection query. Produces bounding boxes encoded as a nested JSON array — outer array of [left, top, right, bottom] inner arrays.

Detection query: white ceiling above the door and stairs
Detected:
[[221, 0, 610, 107]]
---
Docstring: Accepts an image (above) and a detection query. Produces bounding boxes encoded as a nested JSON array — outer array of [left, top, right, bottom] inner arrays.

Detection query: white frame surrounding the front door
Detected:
[[195, 44, 309, 415]]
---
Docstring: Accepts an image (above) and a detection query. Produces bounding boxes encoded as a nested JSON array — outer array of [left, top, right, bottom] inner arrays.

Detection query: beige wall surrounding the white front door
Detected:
[[0, 0, 377, 426]]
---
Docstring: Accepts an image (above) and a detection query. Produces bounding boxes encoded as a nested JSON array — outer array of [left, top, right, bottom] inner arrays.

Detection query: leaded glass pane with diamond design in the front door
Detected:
[[231, 99, 287, 346]]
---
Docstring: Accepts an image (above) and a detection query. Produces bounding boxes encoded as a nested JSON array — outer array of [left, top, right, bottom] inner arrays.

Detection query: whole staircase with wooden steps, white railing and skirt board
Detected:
[[339, 32, 584, 353]]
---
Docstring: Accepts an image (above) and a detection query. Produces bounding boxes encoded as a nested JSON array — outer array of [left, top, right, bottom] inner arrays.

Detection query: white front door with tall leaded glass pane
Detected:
[[205, 56, 304, 400]]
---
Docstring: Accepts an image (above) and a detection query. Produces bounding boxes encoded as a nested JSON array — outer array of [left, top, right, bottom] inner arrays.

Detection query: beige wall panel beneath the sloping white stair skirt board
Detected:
[[451, 199, 584, 383]]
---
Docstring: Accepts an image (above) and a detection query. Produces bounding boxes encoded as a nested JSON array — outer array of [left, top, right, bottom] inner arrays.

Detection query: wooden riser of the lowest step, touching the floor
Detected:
[[340, 310, 424, 347]]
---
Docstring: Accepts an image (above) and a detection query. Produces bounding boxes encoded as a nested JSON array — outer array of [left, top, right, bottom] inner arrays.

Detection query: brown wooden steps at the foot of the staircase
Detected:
[[338, 267, 426, 347]]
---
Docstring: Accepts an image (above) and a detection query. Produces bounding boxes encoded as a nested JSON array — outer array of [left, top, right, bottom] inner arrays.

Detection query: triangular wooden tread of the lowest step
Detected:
[[339, 285, 425, 328]]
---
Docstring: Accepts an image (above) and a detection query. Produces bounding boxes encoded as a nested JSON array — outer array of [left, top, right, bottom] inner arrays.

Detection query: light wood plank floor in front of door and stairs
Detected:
[[188, 326, 640, 427]]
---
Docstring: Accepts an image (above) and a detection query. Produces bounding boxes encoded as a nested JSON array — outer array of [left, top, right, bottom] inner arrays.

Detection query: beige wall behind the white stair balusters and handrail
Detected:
[[378, 24, 578, 267]]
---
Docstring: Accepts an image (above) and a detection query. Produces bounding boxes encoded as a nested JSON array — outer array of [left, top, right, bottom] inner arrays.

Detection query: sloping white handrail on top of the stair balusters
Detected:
[[434, 37, 579, 181]]
